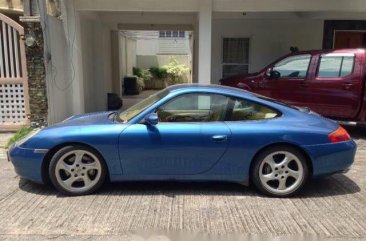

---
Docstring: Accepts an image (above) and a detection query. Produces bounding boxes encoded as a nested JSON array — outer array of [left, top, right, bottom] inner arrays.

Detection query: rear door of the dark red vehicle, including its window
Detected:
[[308, 53, 364, 118]]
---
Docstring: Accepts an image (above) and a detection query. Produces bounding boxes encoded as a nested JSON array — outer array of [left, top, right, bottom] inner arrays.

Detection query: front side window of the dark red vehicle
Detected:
[[272, 54, 311, 78]]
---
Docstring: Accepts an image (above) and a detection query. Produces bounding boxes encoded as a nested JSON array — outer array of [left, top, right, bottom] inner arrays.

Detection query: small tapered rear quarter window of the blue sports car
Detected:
[[229, 99, 280, 121]]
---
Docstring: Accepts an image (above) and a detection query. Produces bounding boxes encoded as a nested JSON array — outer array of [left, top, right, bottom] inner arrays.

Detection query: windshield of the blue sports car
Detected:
[[118, 89, 169, 122]]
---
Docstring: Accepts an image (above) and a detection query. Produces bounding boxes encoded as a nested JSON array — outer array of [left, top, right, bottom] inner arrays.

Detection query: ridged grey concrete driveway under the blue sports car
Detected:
[[0, 129, 366, 241]]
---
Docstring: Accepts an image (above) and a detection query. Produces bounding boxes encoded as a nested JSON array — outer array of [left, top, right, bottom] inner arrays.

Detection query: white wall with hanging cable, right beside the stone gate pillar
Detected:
[[40, 1, 84, 124]]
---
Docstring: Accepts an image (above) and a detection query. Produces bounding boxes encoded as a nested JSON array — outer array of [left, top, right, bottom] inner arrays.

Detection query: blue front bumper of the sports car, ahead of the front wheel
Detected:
[[8, 145, 45, 183]]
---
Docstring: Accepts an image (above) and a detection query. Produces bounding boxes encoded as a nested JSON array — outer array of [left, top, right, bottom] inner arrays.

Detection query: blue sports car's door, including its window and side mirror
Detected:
[[119, 93, 231, 175]]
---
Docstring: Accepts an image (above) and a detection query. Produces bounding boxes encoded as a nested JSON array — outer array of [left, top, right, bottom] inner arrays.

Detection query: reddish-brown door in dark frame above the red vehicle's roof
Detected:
[[334, 31, 366, 49]]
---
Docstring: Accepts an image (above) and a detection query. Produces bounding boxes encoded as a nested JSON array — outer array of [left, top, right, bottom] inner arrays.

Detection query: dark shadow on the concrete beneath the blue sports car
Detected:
[[19, 174, 361, 198]]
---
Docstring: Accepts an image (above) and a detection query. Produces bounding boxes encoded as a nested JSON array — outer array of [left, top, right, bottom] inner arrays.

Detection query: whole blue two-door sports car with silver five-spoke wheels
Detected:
[[8, 85, 356, 197]]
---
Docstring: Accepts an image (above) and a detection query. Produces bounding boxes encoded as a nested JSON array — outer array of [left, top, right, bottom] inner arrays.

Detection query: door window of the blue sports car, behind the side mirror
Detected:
[[156, 94, 229, 122]]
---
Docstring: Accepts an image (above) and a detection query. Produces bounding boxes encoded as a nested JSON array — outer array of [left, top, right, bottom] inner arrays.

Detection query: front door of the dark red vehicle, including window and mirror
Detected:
[[257, 54, 312, 106]]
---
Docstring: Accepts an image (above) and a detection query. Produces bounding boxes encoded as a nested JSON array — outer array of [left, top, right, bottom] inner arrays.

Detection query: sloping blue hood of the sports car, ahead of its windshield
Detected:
[[50, 111, 116, 128]]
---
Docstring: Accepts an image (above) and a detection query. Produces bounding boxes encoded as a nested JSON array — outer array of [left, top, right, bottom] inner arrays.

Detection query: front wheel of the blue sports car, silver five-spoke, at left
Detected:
[[49, 145, 106, 195]]
